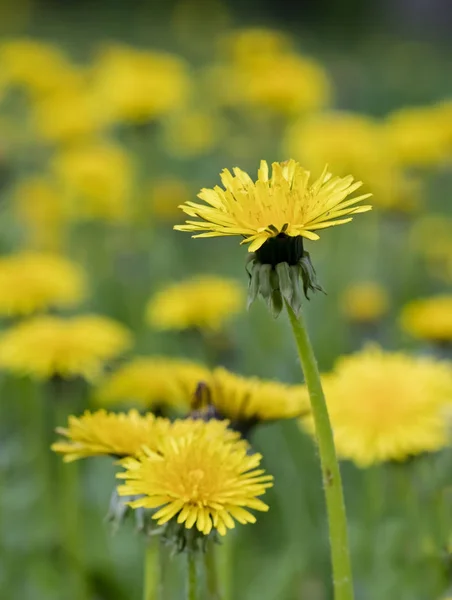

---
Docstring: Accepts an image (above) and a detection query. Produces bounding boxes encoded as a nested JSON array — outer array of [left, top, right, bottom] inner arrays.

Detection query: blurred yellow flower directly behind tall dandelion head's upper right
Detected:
[[284, 111, 419, 212]]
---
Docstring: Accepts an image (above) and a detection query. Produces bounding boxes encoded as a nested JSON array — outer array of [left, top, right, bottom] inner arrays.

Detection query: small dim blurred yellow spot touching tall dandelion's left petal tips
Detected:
[[144, 177, 192, 220]]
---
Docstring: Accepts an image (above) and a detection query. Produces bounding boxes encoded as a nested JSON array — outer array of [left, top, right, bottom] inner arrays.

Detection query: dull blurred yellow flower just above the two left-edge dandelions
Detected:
[[14, 175, 67, 252]]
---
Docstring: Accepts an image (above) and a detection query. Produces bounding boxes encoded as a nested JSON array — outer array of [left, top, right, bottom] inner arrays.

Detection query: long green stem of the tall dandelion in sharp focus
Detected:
[[286, 302, 353, 600]]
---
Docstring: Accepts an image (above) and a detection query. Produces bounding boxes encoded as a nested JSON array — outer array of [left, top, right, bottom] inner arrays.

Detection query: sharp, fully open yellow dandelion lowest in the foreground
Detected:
[[118, 421, 273, 535]]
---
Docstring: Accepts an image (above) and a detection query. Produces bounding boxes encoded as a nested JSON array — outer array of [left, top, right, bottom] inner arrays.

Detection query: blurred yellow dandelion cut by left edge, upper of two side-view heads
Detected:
[[0, 252, 86, 317]]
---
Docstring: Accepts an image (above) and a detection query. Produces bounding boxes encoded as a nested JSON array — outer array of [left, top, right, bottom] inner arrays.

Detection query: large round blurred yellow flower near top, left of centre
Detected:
[[93, 45, 191, 123]]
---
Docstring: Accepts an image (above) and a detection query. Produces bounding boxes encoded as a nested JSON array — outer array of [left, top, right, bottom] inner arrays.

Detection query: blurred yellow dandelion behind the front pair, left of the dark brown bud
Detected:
[[96, 356, 209, 412]]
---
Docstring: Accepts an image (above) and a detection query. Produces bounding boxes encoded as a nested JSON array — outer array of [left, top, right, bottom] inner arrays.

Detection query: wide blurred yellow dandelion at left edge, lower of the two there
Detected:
[[0, 315, 131, 380]]
